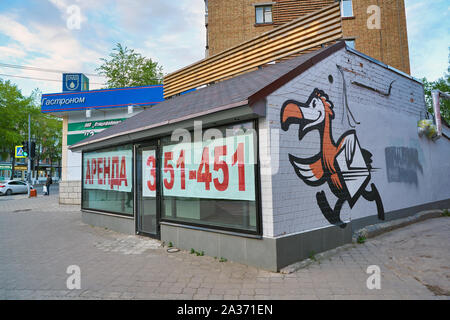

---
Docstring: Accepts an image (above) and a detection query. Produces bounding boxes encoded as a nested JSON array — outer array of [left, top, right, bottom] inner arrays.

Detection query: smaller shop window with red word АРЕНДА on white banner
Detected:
[[82, 145, 133, 216]]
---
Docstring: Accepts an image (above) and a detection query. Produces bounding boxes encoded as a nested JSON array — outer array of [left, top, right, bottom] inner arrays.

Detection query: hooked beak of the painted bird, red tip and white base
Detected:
[[281, 102, 321, 131]]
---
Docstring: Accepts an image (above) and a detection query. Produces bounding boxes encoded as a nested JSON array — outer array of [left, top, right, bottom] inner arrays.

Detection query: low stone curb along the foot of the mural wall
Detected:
[[279, 210, 444, 274]]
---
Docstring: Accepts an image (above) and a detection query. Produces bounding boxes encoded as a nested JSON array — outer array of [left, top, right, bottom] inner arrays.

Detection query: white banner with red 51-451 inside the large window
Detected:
[[157, 134, 255, 201]]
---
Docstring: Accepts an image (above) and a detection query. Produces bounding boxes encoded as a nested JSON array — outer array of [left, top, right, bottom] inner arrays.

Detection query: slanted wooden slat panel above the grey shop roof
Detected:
[[164, 3, 342, 98]]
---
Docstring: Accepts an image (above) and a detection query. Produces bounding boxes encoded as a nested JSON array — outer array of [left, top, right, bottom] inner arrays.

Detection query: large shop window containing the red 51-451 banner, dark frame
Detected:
[[160, 122, 258, 233]]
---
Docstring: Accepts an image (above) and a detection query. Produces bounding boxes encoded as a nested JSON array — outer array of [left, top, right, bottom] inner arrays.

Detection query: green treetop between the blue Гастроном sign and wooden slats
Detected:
[[96, 43, 163, 88]]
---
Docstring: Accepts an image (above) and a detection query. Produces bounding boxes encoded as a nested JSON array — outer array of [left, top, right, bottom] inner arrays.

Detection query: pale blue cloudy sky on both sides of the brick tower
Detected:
[[0, 0, 450, 95]]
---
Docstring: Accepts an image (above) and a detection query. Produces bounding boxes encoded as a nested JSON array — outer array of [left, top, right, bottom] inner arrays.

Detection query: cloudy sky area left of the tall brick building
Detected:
[[0, 0, 206, 92]]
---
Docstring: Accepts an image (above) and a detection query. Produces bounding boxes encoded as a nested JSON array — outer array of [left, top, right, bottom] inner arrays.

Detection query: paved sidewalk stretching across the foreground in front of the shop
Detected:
[[0, 195, 450, 299]]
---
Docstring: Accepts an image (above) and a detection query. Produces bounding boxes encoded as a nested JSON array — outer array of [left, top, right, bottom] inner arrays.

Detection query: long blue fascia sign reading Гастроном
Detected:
[[41, 85, 164, 112]]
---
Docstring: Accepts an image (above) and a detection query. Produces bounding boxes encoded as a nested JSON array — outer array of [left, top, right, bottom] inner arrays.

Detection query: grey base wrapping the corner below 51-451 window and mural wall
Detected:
[[161, 199, 450, 272]]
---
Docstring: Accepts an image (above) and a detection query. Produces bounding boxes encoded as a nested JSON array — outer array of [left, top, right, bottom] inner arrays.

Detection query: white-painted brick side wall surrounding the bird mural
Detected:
[[260, 49, 450, 237]]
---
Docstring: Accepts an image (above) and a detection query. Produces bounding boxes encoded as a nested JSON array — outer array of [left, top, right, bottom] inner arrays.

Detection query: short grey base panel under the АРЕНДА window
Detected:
[[81, 210, 136, 234]]
